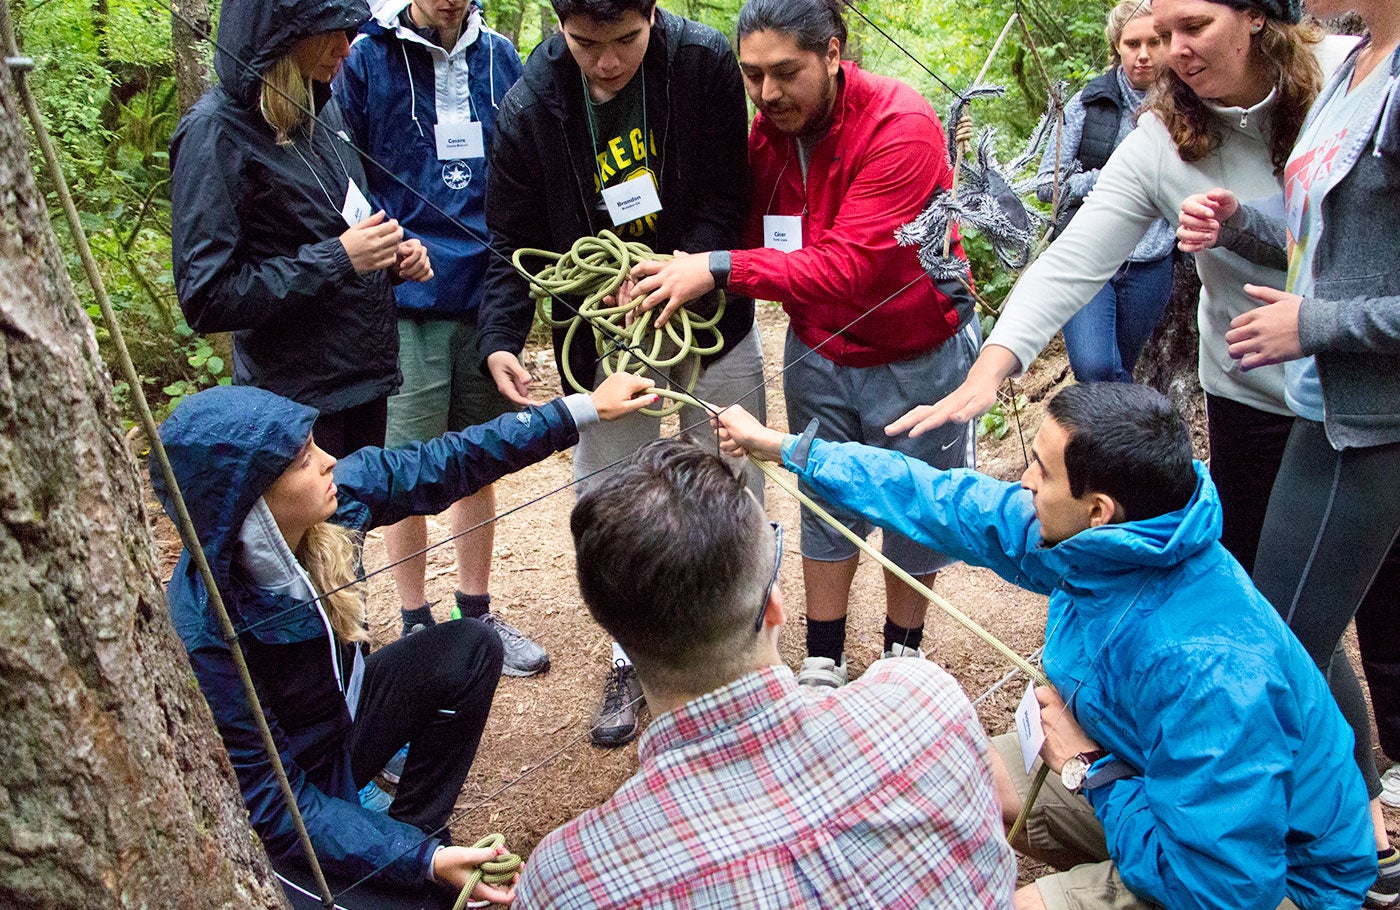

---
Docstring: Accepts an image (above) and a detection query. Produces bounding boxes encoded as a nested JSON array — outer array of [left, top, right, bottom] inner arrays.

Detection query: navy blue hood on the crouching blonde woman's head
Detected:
[[151, 380, 316, 596]]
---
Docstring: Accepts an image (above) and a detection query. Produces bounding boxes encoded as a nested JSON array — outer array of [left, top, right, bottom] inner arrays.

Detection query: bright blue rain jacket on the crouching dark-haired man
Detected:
[[783, 437, 1376, 910]]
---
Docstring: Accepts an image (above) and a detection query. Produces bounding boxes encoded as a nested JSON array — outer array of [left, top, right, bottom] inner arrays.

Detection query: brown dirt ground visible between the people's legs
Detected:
[[150, 305, 1400, 878]]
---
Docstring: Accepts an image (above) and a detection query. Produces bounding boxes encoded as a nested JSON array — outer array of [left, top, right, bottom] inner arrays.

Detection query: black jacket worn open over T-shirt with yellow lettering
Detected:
[[476, 8, 753, 384]]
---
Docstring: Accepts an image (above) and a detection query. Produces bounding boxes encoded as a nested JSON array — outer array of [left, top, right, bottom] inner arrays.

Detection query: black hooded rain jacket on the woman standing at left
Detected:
[[171, 0, 400, 413]]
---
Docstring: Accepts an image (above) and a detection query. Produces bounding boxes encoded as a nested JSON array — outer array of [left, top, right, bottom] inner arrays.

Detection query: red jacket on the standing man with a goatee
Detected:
[[729, 62, 966, 367]]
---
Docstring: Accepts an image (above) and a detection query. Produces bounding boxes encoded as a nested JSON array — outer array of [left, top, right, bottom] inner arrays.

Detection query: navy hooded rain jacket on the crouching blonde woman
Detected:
[[151, 386, 578, 885]]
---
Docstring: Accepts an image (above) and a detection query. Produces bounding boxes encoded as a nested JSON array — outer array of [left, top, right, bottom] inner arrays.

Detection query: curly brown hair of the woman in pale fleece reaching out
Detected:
[[1145, 20, 1323, 175]]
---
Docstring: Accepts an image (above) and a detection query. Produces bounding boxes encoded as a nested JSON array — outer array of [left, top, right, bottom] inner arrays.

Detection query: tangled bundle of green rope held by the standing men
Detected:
[[511, 231, 724, 417]]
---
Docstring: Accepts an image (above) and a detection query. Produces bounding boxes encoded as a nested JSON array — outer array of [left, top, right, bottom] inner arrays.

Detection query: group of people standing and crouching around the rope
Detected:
[[158, 0, 1400, 907]]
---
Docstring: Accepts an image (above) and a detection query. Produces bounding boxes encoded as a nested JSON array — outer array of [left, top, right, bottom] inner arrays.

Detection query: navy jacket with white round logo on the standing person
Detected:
[[332, 0, 521, 319]]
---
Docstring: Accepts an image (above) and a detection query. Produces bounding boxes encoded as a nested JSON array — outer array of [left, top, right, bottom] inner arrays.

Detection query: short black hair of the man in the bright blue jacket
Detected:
[[1046, 382, 1197, 521]]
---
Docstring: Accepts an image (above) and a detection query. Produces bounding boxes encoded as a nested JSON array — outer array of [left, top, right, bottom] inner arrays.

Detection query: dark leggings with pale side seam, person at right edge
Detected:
[[1254, 417, 1400, 798]]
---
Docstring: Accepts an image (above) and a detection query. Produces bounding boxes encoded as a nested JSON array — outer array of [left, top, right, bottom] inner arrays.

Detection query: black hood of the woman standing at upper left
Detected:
[[214, 0, 370, 108]]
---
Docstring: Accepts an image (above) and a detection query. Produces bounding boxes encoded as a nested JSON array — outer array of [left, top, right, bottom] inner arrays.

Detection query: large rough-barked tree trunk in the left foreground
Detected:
[[0, 66, 286, 910]]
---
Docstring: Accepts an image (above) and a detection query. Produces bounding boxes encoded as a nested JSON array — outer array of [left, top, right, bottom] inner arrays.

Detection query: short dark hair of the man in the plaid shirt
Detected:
[[570, 437, 776, 672]]
